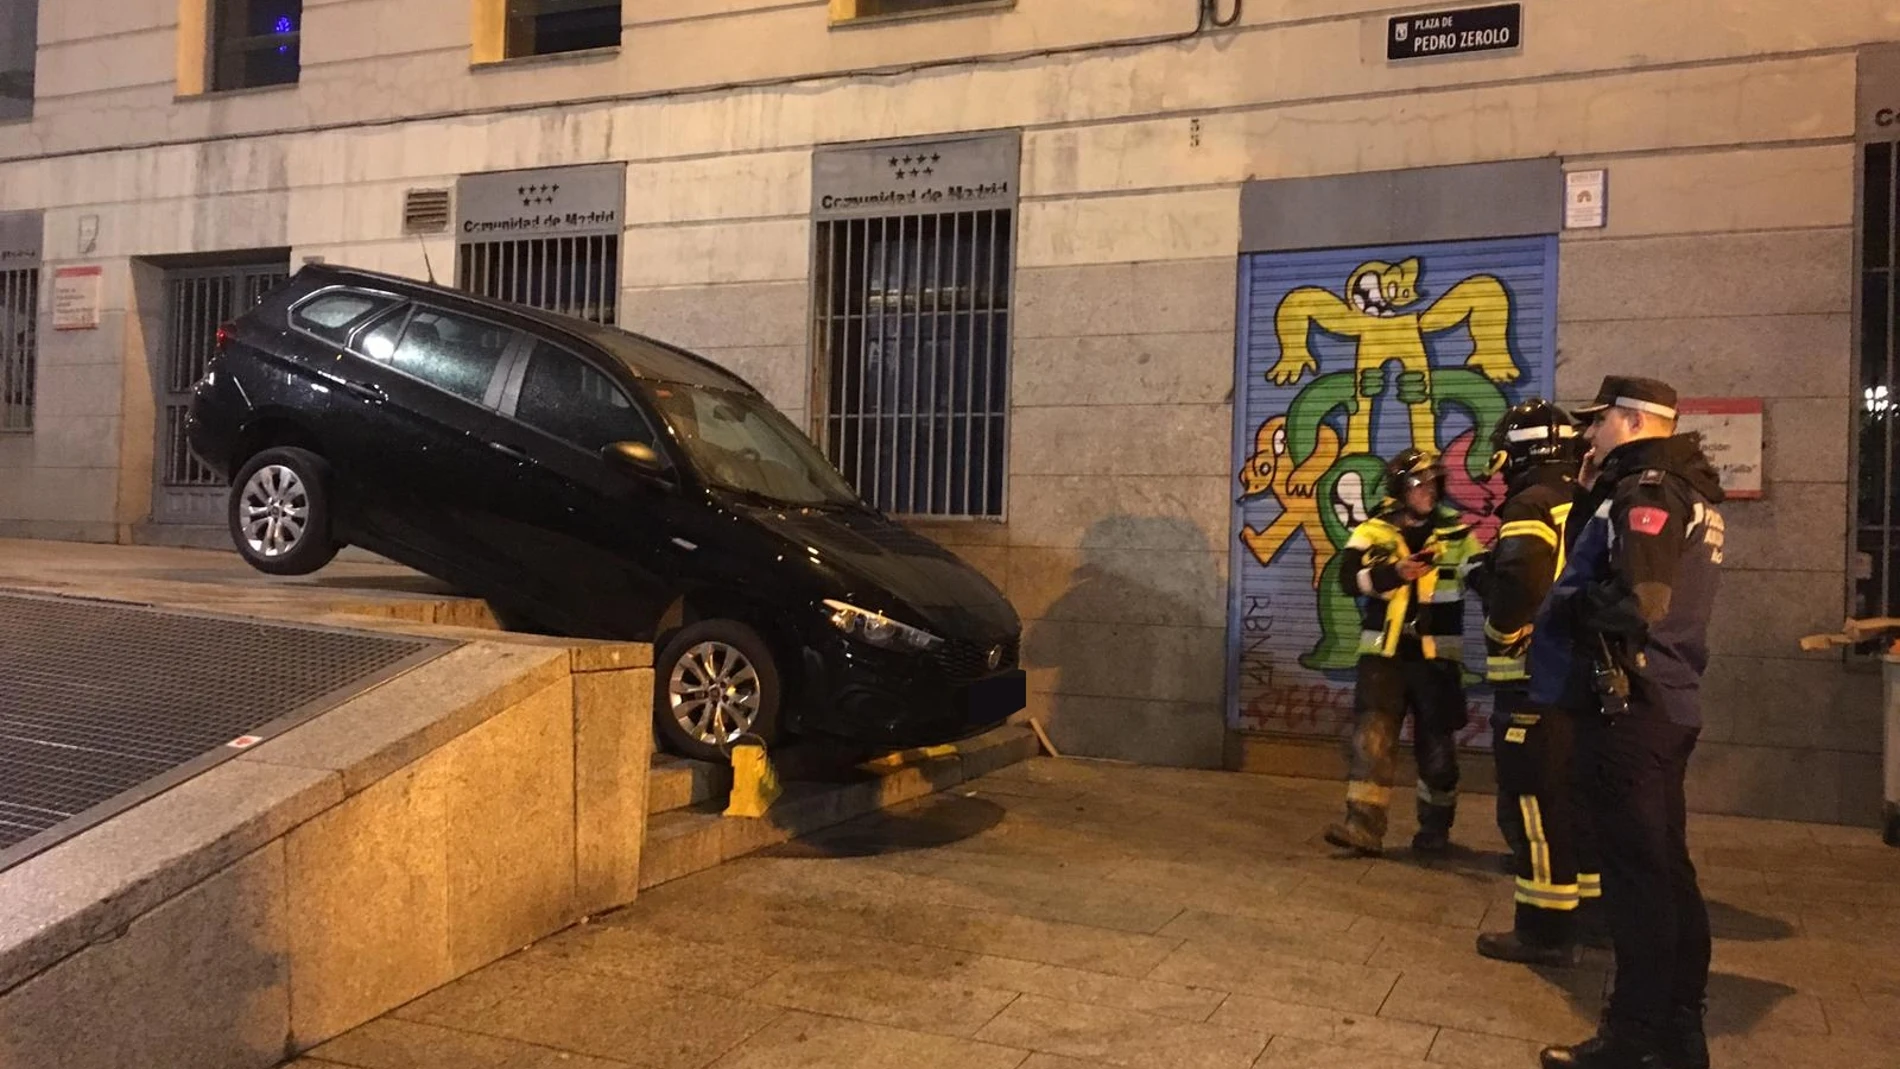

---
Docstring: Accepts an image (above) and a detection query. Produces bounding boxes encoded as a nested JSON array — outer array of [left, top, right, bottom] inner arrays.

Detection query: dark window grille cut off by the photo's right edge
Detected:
[[1853, 142, 1900, 617]]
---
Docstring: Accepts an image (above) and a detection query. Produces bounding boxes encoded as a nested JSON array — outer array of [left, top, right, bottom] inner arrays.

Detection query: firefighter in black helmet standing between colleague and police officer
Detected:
[[1471, 399, 1602, 965]]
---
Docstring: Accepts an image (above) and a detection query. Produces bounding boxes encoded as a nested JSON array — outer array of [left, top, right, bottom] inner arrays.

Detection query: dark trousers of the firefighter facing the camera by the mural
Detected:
[[1345, 644, 1465, 837]]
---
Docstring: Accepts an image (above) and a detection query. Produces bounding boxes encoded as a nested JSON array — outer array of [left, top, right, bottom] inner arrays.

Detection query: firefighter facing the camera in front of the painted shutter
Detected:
[[1326, 448, 1480, 854]]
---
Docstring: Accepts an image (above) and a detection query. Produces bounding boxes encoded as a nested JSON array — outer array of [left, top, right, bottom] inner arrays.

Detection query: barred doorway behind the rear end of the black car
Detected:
[[152, 262, 291, 526]]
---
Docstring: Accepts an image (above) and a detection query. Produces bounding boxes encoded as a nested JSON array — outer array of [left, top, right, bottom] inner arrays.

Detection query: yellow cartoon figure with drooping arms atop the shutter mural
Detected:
[[1267, 256, 1522, 454]]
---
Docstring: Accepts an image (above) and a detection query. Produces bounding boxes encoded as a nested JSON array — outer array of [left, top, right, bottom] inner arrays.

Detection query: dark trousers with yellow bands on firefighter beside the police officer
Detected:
[[1492, 685, 1604, 946]]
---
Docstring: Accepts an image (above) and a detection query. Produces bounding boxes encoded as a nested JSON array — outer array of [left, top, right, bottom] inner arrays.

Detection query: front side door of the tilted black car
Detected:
[[482, 340, 684, 638]]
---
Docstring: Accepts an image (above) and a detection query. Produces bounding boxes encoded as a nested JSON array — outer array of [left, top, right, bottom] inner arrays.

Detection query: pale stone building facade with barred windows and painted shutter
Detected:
[[0, 0, 1900, 822]]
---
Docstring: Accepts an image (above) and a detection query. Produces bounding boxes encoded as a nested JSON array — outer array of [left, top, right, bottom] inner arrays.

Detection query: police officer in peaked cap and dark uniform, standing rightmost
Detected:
[[1530, 376, 1723, 1069]]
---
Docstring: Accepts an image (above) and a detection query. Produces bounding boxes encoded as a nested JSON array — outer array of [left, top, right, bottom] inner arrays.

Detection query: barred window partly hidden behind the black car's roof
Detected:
[[456, 235, 619, 327]]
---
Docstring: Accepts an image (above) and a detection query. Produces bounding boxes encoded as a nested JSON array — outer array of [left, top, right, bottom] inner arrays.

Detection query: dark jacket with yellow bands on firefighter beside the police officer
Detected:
[[1473, 463, 1577, 684]]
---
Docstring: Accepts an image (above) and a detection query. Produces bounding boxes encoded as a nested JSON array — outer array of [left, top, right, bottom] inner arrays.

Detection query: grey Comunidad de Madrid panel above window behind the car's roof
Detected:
[[456, 163, 627, 241]]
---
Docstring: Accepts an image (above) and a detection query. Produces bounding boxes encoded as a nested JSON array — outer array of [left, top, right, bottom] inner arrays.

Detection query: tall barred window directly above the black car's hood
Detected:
[[813, 209, 1013, 518]]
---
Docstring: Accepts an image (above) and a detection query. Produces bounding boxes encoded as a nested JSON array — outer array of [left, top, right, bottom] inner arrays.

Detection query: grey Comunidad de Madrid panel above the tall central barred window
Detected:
[[811, 131, 1022, 218]]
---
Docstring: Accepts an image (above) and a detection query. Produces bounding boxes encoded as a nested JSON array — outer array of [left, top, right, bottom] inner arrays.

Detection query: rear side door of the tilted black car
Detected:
[[327, 296, 521, 596]]
